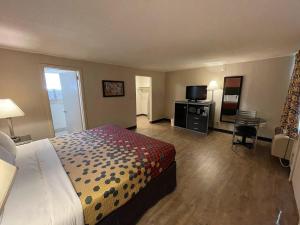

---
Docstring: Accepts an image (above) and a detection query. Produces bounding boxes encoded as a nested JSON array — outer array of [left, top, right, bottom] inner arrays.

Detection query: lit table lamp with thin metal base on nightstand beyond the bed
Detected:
[[0, 99, 25, 139]]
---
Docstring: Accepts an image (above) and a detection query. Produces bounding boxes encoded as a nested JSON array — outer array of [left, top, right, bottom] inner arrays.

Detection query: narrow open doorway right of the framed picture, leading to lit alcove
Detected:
[[135, 76, 152, 128]]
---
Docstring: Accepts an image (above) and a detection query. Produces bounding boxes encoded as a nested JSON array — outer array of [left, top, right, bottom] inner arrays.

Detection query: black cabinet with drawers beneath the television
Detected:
[[174, 100, 215, 134]]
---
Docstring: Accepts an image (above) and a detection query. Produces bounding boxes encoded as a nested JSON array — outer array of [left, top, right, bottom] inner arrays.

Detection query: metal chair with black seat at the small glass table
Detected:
[[232, 111, 259, 148]]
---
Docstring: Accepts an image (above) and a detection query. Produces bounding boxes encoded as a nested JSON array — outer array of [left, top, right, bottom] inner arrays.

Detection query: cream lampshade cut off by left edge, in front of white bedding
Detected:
[[0, 159, 17, 223]]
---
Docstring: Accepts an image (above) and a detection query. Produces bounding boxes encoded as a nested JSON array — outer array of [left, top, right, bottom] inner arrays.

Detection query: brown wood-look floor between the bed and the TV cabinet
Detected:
[[136, 117, 298, 225]]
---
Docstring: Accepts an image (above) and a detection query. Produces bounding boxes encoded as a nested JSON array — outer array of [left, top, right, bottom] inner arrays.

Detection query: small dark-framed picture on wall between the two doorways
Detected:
[[102, 80, 125, 97]]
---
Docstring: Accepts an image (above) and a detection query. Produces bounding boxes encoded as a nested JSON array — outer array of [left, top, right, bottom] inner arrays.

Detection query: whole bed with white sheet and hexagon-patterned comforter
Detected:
[[1, 125, 176, 225]]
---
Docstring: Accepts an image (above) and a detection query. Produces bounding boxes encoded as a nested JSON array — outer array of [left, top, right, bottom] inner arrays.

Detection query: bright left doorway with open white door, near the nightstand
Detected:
[[44, 67, 85, 136]]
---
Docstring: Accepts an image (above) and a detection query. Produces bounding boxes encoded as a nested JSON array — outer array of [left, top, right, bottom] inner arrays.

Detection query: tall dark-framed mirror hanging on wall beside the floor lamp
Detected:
[[220, 76, 243, 123]]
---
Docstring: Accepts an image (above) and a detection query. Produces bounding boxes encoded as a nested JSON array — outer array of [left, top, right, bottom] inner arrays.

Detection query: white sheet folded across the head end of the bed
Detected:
[[0, 139, 84, 225]]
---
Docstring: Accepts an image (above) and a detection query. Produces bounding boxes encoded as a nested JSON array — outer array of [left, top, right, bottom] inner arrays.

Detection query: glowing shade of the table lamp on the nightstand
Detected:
[[0, 99, 25, 119]]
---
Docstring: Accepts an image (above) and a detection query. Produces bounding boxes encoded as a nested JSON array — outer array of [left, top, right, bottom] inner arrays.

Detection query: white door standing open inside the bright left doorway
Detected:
[[59, 70, 83, 133]]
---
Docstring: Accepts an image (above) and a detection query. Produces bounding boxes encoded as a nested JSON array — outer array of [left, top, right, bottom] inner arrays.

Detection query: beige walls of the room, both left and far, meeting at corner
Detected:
[[0, 49, 293, 139]]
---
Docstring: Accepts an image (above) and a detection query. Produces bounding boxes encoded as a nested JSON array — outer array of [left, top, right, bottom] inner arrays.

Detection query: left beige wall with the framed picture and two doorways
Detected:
[[0, 49, 165, 139]]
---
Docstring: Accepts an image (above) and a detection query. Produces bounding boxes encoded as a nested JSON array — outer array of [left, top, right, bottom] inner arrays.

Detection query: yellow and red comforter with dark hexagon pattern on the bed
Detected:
[[50, 125, 175, 225]]
